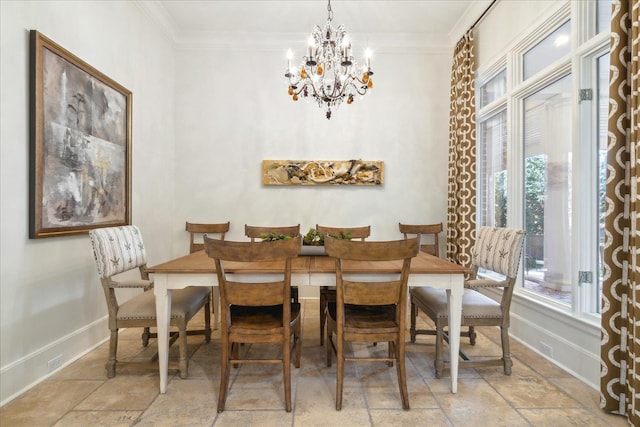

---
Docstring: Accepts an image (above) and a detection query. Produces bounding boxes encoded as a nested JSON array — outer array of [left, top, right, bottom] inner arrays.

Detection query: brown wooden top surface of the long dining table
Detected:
[[147, 251, 464, 274]]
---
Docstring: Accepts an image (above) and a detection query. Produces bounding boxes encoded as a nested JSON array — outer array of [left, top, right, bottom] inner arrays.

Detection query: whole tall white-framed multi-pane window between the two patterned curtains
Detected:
[[477, 0, 611, 323]]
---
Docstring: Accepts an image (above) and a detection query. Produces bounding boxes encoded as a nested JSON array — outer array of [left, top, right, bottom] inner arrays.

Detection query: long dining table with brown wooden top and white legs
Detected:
[[147, 250, 465, 394]]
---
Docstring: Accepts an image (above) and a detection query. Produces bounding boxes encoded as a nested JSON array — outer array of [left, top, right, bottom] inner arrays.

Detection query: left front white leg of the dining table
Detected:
[[153, 274, 171, 394]]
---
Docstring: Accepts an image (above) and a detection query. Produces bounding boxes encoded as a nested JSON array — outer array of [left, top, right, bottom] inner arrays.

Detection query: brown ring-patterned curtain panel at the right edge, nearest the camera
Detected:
[[600, 0, 640, 426]]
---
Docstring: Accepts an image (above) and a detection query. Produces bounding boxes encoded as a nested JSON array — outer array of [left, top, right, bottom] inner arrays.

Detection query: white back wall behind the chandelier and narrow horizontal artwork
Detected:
[[174, 46, 451, 253]]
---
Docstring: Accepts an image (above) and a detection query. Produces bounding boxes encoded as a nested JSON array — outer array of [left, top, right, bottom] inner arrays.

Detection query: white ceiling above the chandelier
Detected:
[[142, 0, 491, 47]]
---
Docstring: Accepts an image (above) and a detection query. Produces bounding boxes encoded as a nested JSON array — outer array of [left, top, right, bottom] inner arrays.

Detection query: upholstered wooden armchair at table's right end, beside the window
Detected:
[[410, 227, 525, 378]]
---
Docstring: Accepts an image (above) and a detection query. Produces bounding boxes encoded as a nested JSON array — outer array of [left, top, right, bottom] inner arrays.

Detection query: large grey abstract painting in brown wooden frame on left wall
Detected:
[[29, 30, 132, 238]]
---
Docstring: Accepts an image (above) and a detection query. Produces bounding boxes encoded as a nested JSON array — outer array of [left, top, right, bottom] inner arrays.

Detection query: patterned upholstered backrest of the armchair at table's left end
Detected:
[[89, 225, 147, 279]]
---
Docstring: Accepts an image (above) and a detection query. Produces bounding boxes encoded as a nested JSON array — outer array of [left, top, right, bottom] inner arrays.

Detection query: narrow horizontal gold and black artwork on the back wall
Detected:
[[262, 159, 384, 185]]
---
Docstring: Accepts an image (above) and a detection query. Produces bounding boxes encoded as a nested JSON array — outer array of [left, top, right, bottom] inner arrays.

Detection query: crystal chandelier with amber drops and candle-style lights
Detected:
[[284, 0, 373, 119]]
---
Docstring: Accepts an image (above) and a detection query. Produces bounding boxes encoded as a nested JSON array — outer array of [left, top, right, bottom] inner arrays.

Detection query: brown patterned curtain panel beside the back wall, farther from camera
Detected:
[[447, 30, 476, 266]]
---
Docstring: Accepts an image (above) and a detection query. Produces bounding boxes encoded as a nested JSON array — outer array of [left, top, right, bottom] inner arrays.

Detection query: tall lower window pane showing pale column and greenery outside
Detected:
[[523, 75, 572, 304]]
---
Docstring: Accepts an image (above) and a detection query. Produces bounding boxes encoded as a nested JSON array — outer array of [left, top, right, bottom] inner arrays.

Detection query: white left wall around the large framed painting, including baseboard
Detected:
[[0, 1, 175, 404]]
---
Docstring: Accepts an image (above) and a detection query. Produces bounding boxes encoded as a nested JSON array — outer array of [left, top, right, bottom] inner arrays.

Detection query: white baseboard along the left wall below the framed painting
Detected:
[[0, 316, 109, 407]]
